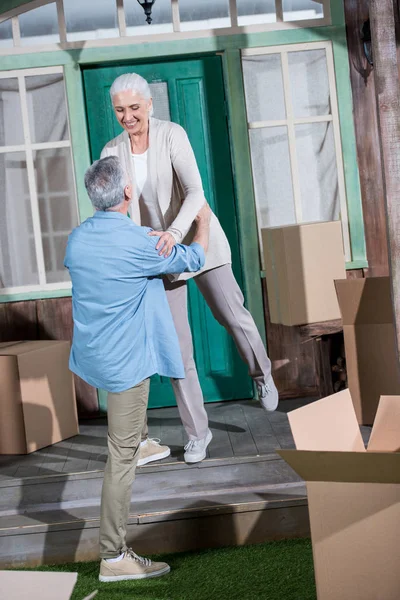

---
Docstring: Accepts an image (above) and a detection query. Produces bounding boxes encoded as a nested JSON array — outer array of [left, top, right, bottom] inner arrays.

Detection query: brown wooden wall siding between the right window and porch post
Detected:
[[344, 0, 389, 277]]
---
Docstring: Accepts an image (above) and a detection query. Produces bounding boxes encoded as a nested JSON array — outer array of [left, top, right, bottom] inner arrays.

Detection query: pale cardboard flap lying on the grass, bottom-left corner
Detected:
[[0, 571, 97, 600]]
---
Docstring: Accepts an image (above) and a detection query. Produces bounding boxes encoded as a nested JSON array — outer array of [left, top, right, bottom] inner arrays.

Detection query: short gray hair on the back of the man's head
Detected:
[[85, 156, 127, 210]]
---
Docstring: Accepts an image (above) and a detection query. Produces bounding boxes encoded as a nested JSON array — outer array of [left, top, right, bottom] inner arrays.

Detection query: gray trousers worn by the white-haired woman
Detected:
[[164, 265, 271, 440]]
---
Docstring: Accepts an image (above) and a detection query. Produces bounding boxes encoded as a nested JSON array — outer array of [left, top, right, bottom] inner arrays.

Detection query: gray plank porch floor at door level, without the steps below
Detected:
[[0, 398, 313, 481]]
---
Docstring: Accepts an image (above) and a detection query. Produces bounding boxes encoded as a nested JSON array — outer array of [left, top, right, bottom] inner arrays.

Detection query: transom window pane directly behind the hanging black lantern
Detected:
[[124, 0, 173, 36]]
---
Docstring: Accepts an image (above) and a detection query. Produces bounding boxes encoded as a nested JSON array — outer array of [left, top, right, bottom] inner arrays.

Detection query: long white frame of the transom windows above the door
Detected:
[[0, 0, 332, 56]]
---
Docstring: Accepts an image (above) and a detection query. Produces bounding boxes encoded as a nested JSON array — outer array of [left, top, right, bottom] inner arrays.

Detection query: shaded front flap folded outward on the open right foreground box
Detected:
[[277, 450, 400, 483]]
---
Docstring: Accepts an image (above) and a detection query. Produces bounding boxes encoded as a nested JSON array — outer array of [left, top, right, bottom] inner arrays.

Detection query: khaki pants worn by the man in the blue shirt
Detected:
[[100, 379, 150, 558]]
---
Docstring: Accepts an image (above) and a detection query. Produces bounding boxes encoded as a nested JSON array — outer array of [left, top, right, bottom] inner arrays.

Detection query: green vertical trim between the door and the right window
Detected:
[[223, 50, 266, 342]]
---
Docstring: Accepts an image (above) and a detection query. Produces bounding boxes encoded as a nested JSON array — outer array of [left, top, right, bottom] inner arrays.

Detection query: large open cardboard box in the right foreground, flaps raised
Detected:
[[278, 390, 400, 600]]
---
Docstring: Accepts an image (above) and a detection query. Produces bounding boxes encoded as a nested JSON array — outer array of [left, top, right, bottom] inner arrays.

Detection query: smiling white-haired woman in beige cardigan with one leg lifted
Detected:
[[101, 73, 278, 464]]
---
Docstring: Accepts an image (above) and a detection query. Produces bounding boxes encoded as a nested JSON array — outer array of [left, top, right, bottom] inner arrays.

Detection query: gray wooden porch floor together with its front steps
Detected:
[[0, 398, 370, 568]]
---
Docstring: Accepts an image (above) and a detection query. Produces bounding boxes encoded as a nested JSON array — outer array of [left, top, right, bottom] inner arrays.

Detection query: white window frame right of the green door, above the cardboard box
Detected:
[[241, 42, 352, 262]]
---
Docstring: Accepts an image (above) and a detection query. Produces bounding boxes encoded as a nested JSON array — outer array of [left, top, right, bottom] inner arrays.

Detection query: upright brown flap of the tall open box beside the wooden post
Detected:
[[335, 277, 394, 325]]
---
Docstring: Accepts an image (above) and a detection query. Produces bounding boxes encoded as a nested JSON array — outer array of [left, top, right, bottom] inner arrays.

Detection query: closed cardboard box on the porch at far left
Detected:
[[0, 341, 79, 454]]
